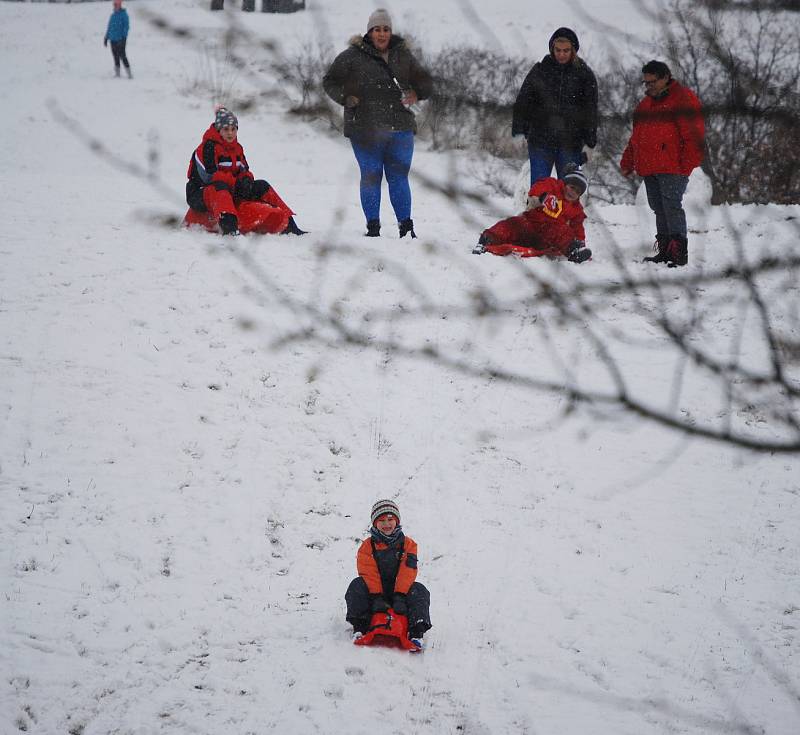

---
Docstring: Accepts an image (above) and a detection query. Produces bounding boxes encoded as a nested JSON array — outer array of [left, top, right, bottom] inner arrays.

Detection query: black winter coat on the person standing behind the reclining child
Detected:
[[511, 55, 597, 151]]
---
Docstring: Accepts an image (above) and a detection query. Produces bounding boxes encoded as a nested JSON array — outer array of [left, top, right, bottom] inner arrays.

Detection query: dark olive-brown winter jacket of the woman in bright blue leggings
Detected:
[[322, 35, 433, 138]]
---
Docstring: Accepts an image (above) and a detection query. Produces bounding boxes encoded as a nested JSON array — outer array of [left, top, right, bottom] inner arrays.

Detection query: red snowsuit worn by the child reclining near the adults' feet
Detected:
[[483, 177, 586, 258]]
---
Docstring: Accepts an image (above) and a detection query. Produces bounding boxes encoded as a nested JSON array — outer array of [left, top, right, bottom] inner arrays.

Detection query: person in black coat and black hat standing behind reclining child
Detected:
[[511, 28, 597, 184]]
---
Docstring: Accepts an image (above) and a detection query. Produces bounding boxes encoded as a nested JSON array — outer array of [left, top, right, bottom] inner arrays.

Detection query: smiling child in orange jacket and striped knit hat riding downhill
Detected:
[[344, 500, 431, 648]]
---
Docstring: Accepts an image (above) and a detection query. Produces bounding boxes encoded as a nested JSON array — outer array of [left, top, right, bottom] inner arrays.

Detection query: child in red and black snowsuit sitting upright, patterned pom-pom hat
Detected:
[[184, 107, 305, 235]]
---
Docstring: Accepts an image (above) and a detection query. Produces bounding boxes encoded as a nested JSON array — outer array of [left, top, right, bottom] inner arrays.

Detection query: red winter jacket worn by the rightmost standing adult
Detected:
[[619, 79, 705, 176]]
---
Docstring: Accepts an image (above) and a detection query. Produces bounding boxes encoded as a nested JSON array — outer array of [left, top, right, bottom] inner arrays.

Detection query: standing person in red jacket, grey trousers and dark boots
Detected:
[[620, 61, 705, 267]]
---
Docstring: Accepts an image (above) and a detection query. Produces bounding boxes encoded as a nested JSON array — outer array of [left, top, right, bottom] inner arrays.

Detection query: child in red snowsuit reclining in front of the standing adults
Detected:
[[472, 164, 592, 263]]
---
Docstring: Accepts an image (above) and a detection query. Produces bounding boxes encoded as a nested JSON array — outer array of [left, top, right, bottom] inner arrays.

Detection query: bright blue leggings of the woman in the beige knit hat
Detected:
[[350, 130, 414, 222]]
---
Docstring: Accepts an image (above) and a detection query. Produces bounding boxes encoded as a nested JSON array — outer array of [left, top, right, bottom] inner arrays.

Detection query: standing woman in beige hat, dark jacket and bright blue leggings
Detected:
[[323, 9, 433, 237]]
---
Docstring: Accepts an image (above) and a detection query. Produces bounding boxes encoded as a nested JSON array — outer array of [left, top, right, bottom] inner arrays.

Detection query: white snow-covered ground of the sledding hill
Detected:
[[0, 0, 800, 735]]
